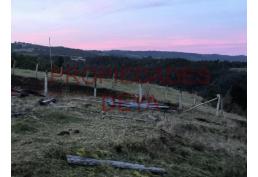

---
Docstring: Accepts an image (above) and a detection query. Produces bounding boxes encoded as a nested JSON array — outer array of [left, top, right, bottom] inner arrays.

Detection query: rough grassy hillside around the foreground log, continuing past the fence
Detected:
[[12, 70, 246, 177]]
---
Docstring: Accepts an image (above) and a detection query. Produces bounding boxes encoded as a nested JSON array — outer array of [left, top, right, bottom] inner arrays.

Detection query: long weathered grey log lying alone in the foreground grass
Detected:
[[66, 155, 166, 174]]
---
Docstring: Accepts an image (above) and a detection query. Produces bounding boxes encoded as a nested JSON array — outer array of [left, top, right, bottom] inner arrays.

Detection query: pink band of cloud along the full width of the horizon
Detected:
[[12, 29, 247, 55]]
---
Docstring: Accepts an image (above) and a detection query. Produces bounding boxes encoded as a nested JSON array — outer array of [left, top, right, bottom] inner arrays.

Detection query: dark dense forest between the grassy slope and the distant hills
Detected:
[[12, 53, 247, 115]]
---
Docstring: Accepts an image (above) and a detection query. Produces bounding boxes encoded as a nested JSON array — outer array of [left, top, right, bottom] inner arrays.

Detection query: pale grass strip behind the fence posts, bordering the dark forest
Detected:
[[12, 68, 246, 121]]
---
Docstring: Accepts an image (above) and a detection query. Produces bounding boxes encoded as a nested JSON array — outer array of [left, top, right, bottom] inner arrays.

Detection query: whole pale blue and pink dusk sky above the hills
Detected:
[[12, 0, 246, 55]]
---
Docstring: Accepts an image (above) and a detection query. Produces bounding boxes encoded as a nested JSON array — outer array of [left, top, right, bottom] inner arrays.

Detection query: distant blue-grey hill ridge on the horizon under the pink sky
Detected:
[[12, 42, 247, 62]]
